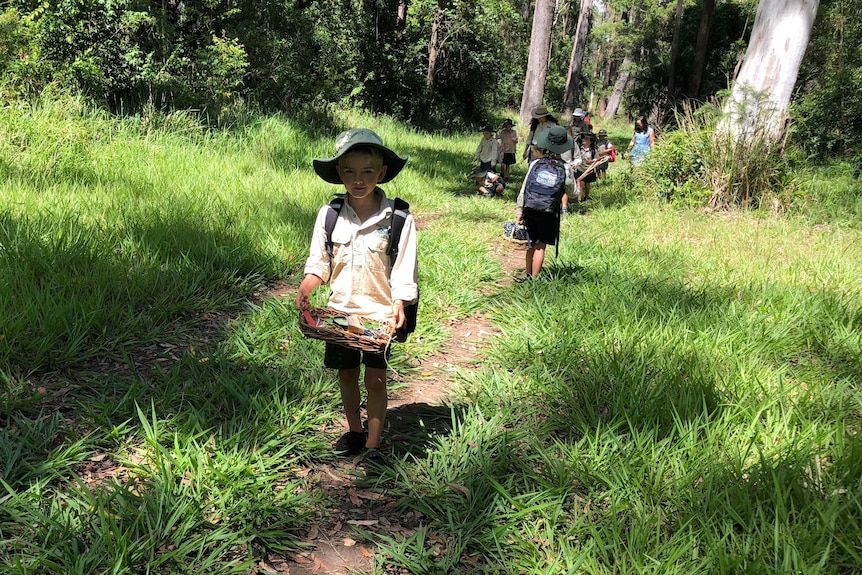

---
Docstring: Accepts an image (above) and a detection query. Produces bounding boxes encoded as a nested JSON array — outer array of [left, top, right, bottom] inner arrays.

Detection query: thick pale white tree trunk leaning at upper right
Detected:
[[722, 0, 819, 142]]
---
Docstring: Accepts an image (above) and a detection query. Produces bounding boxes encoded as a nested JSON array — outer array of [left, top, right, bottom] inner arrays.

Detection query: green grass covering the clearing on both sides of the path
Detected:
[[0, 100, 862, 575]]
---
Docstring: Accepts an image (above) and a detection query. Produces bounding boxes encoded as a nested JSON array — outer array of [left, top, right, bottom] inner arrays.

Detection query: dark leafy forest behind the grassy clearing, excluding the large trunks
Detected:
[[0, 0, 862, 162]]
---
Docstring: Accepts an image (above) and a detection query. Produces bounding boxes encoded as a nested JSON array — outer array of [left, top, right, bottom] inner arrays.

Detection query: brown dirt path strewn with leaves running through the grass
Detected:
[[258, 241, 524, 575]]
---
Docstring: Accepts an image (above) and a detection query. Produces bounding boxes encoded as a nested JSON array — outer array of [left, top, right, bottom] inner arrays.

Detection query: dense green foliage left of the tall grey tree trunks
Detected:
[[0, 0, 528, 128]]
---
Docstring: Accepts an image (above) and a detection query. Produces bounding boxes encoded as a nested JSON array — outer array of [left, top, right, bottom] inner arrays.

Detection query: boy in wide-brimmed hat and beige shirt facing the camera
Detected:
[[296, 129, 419, 460]]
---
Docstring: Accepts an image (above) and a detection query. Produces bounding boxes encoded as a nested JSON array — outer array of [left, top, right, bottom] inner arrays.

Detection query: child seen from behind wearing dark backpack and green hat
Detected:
[[517, 126, 574, 278]]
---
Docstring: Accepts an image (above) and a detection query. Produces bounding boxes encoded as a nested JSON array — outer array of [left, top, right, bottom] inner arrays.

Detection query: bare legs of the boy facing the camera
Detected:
[[338, 366, 388, 447]]
